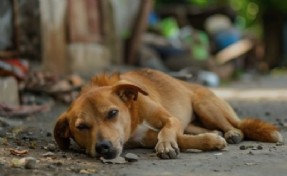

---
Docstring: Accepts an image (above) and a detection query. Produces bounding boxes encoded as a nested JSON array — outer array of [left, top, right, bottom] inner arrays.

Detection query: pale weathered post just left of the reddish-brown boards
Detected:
[[40, 0, 69, 74]]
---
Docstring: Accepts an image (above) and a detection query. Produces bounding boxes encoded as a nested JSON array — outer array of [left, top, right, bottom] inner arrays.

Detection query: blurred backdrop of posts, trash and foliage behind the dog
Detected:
[[0, 0, 287, 107]]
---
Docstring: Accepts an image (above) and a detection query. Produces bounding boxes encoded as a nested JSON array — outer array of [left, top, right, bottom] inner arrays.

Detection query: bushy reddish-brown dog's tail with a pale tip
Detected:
[[238, 118, 283, 143]]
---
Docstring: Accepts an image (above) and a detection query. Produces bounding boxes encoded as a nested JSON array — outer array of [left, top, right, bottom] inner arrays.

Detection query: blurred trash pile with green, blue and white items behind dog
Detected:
[[138, 12, 255, 87]]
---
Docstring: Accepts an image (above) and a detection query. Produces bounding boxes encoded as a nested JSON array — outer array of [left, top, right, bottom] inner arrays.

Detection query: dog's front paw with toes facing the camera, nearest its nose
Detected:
[[155, 141, 179, 159]]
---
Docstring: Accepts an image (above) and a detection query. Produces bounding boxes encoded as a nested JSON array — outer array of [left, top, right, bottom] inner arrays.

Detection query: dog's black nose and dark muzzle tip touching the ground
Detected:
[[96, 140, 118, 159]]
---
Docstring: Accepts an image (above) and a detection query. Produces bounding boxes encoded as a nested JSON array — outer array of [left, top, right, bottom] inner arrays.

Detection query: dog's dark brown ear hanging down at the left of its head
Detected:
[[54, 112, 71, 150]]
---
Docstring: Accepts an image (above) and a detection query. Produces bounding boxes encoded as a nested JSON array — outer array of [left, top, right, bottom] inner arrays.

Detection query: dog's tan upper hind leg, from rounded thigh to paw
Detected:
[[192, 90, 244, 144]]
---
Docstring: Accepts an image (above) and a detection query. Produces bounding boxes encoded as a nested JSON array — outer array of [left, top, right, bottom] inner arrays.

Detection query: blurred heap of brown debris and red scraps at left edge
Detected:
[[0, 59, 84, 119]]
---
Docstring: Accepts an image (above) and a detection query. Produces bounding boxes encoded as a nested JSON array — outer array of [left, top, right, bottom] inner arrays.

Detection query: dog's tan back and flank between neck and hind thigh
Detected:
[[121, 69, 197, 127]]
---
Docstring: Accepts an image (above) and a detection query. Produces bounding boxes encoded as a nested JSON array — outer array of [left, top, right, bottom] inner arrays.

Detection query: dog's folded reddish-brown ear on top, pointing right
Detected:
[[113, 84, 148, 102]]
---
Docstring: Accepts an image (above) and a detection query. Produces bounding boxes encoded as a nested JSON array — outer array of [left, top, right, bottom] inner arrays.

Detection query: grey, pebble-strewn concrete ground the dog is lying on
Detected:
[[0, 72, 287, 176]]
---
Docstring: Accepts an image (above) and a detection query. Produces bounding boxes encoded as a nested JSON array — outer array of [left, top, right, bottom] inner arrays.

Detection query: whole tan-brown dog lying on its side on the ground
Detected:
[[54, 69, 283, 159]]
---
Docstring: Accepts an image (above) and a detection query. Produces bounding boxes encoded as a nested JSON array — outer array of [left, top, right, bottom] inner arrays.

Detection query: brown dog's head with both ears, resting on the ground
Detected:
[[54, 84, 147, 159]]
